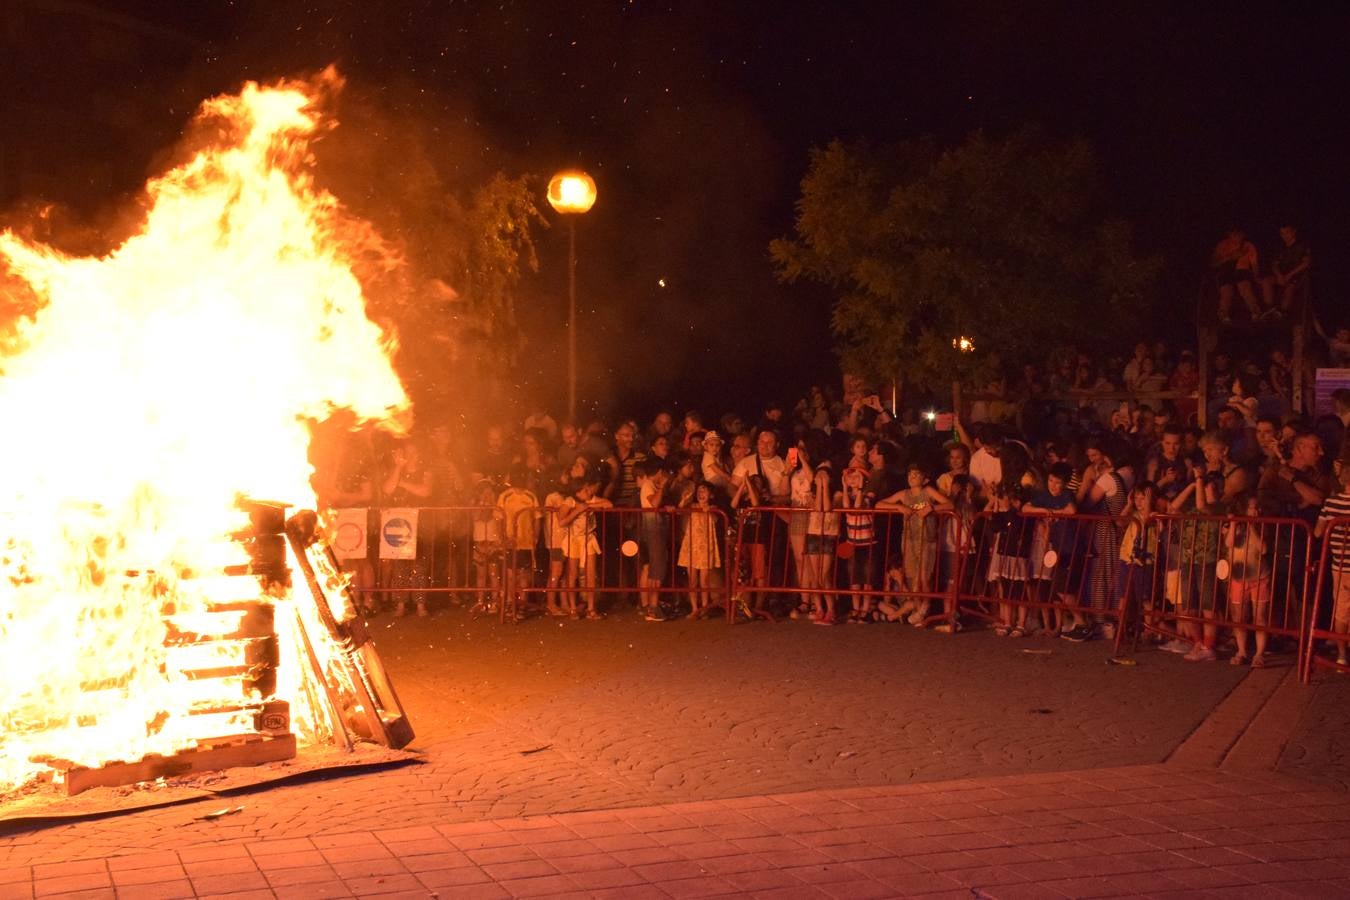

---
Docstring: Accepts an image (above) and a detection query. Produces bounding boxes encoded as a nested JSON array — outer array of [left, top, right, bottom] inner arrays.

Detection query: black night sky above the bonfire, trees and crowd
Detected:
[[0, 0, 1350, 414]]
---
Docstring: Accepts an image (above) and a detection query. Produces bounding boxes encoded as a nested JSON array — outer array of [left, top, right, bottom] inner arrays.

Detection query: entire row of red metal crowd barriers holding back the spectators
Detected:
[[329, 505, 1350, 681]]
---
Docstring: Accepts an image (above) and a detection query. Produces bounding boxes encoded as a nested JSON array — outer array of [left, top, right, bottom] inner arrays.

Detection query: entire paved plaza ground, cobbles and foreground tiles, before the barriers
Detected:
[[0, 610, 1350, 897]]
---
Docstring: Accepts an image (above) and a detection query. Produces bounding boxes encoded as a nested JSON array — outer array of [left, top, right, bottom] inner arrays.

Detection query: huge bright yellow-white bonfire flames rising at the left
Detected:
[[0, 73, 408, 789]]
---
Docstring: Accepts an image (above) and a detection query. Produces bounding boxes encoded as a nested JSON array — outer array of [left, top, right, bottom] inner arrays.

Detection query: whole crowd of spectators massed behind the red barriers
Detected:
[[323, 325, 1350, 665]]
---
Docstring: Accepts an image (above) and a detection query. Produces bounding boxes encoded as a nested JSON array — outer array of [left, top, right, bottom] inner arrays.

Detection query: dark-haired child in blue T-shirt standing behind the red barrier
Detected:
[[1022, 461, 1087, 634]]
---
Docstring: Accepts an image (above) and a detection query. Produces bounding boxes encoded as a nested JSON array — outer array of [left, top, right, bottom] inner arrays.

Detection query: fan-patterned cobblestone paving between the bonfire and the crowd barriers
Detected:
[[0, 610, 1242, 866]]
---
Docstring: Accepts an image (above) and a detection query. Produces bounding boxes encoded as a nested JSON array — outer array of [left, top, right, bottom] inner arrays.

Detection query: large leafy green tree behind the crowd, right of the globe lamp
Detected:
[[770, 130, 1157, 387]]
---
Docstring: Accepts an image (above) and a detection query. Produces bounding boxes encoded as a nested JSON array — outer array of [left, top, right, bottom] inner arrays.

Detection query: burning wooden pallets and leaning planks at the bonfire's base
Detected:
[[42, 502, 413, 795]]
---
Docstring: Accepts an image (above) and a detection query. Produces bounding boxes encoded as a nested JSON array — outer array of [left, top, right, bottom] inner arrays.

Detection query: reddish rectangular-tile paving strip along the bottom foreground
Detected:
[[0, 765, 1350, 900]]
